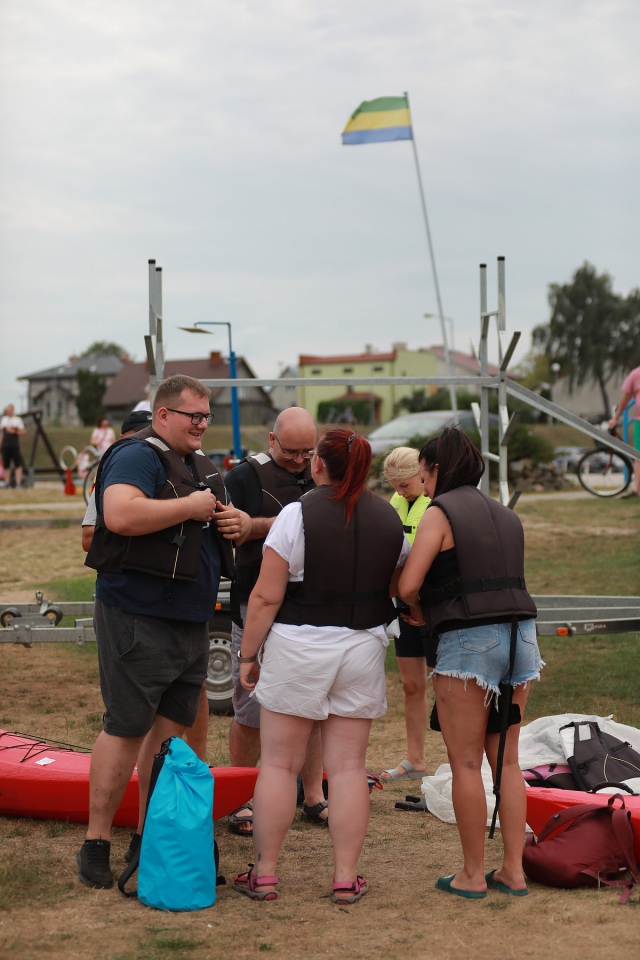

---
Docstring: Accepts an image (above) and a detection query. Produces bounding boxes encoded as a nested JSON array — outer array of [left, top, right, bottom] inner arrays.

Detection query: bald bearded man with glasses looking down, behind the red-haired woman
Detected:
[[217, 407, 327, 837]]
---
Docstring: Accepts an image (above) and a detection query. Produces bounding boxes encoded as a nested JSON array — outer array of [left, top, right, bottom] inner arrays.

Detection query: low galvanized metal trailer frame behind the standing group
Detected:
[[0, 589, 640, 647]]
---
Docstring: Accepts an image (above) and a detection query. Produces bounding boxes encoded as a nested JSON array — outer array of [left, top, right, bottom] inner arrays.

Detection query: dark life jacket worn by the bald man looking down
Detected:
[[236, 451, 315, 568]]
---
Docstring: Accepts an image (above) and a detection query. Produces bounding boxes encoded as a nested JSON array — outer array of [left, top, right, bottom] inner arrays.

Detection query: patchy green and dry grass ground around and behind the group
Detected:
[[0, 491, 640, 960]]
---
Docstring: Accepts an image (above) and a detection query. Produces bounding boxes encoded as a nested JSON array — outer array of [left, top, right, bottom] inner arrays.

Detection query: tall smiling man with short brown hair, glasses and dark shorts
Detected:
[[77, 375, 237, 888]]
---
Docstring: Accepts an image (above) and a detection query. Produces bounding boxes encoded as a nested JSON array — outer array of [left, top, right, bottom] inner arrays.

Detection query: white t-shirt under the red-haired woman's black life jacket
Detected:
[[262, 501, 410, 647]]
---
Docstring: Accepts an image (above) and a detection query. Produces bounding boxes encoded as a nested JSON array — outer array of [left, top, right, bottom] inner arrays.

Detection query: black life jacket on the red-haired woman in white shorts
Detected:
[[275, 485, 404, 630]]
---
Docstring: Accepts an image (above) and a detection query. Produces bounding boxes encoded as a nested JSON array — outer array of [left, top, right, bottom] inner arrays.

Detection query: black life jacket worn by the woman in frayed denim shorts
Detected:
[[420, 485, 537, 636]]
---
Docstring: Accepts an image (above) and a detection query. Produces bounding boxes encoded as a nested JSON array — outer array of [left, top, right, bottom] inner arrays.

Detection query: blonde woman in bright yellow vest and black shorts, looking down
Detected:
[[381, 447, 429, 781]]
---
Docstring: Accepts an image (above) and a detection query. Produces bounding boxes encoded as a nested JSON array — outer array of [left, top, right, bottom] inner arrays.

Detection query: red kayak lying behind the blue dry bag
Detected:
[[0, 730, 258, 827]]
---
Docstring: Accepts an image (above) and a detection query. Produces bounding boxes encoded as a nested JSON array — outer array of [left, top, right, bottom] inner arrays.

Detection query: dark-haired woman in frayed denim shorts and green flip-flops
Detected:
[[399, 428, 544, 899]]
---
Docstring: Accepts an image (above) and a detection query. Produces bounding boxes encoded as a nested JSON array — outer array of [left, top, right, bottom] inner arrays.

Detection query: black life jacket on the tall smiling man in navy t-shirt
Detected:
[[85, 427, 233, 580]]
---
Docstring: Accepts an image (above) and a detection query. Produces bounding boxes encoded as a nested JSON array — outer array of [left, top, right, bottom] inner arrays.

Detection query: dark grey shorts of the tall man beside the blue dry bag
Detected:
[[94, 600, 209, 737]]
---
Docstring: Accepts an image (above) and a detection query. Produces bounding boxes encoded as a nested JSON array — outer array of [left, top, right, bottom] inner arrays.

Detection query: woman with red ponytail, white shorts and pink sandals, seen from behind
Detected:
[[234, 430, 409, 904]]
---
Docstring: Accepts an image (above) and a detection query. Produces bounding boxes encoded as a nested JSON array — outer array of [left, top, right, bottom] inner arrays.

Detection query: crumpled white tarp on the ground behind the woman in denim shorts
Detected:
[[422, 713, 640, 826]]
